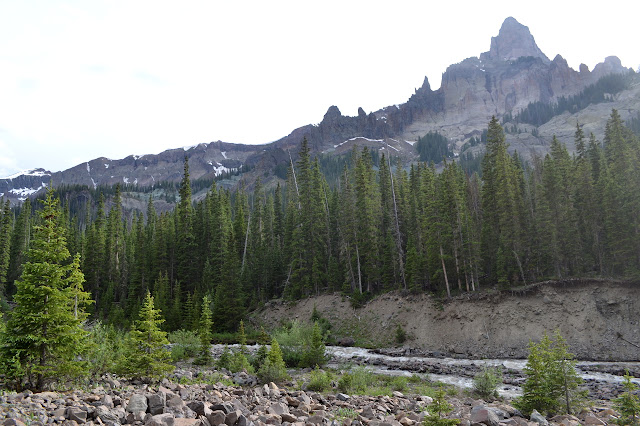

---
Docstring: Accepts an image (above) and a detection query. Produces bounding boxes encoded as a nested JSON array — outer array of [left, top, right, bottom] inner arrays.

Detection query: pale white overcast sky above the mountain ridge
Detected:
[[0, 0, 640, 177]]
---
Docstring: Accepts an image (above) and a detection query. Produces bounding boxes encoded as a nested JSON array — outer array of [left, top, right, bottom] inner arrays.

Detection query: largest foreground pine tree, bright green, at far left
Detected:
[[1, 189, 89, 390]]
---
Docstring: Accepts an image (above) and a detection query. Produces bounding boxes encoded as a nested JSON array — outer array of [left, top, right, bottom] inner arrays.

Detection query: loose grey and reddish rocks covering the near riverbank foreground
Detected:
[[0, 370, 617, 426]]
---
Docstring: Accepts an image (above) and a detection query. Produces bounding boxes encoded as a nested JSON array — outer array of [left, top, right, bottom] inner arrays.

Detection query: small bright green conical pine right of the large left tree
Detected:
[[118, 292, 173, 380]]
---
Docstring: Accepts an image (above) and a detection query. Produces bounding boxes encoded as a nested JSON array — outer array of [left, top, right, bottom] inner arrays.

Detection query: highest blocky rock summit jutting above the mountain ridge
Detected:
[[481, 17, 550, 63]]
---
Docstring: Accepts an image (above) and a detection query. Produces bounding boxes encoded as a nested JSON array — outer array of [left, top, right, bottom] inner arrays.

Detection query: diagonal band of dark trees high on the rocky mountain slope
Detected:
[[503, 71, 638, 126]]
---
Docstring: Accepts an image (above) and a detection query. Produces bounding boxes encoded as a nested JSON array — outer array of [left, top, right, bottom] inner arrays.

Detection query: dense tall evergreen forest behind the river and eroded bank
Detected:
[[0, 110, 640, 331]]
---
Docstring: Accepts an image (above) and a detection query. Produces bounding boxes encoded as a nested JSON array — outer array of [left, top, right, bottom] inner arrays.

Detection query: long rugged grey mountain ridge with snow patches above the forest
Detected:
[[0, 17, 640, 207]]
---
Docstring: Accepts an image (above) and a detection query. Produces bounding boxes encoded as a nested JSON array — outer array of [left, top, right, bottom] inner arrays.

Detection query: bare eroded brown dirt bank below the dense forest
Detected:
[[251, 279, 640, 361]]
